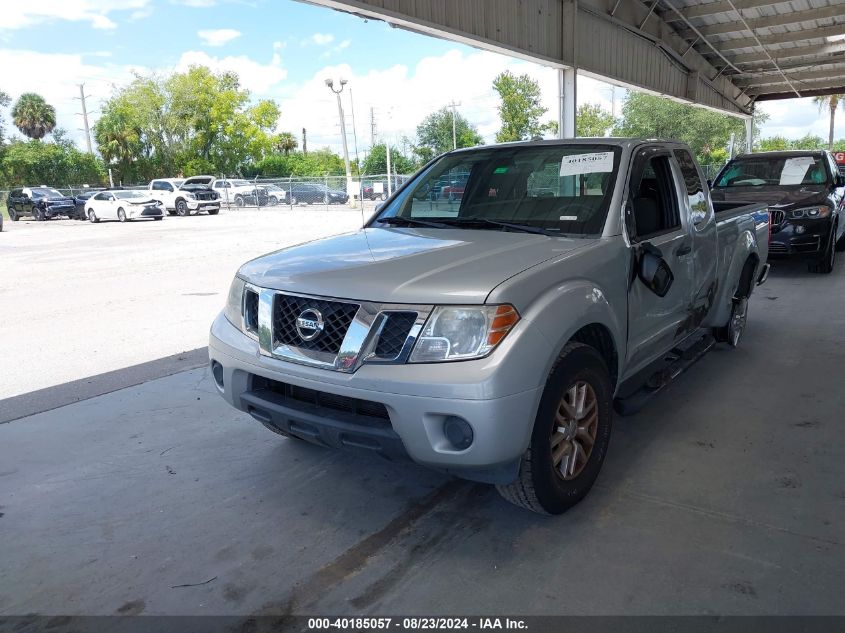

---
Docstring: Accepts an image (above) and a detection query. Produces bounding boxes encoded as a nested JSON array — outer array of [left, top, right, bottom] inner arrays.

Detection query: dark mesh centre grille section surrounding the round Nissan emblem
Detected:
[[273, 293, 360, 354]]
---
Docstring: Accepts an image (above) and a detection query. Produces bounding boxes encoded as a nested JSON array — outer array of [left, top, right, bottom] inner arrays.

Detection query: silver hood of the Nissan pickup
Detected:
[[239, 227, 593, 304]]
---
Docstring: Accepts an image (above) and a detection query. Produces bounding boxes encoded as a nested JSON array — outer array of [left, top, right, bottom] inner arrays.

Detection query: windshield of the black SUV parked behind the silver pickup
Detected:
[[715, 155, 827, 187]]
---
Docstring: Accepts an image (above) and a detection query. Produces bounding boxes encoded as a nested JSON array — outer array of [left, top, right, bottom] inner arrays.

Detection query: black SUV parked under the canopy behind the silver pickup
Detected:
[[711, 151, 845, 273]]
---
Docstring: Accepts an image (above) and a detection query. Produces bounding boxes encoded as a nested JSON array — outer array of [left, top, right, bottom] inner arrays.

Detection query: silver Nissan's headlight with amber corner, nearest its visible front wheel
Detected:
[[410, 304, 519, 363]]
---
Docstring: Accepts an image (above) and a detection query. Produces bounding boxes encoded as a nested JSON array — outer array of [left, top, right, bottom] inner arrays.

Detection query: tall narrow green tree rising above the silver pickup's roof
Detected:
[[493, 70, 556, 143]]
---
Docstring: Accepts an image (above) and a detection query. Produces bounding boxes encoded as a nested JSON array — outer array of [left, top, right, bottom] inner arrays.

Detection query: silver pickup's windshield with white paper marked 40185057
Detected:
[[376, 144, 621, 235]]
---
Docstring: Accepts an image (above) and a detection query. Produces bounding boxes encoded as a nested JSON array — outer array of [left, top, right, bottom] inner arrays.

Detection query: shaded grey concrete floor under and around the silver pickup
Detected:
[[0, 256, 845, 615]]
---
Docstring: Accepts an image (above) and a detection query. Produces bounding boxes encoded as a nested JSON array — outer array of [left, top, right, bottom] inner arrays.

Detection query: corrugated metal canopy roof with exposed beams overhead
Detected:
[[303, 0, 845, 116]]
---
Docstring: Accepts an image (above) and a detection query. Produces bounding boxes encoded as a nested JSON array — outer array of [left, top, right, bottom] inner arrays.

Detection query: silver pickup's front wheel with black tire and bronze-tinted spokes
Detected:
[[497, 342, 613, 514]]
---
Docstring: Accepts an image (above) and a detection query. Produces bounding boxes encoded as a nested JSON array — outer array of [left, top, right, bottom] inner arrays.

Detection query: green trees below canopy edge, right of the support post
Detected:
[[613, 92, 768, 165]]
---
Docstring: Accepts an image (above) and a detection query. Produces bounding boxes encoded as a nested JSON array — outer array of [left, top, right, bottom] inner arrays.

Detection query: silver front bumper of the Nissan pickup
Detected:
[[209, 315, 548, 483]]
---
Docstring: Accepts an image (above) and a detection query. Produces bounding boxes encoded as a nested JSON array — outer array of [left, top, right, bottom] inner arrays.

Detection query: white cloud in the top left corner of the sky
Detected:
[[0, 0, 150, 31]]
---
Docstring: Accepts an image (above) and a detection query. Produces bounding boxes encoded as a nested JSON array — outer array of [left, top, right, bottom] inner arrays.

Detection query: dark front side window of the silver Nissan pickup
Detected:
[[631, 156, 681, 240]]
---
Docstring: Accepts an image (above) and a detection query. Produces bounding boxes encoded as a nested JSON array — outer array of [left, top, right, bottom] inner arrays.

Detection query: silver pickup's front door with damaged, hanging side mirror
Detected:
[[625, 148, 695, 377]]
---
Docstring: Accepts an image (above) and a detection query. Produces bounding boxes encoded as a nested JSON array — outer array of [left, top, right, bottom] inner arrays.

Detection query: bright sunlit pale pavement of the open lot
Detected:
[[0, 201, 374, 398]]
